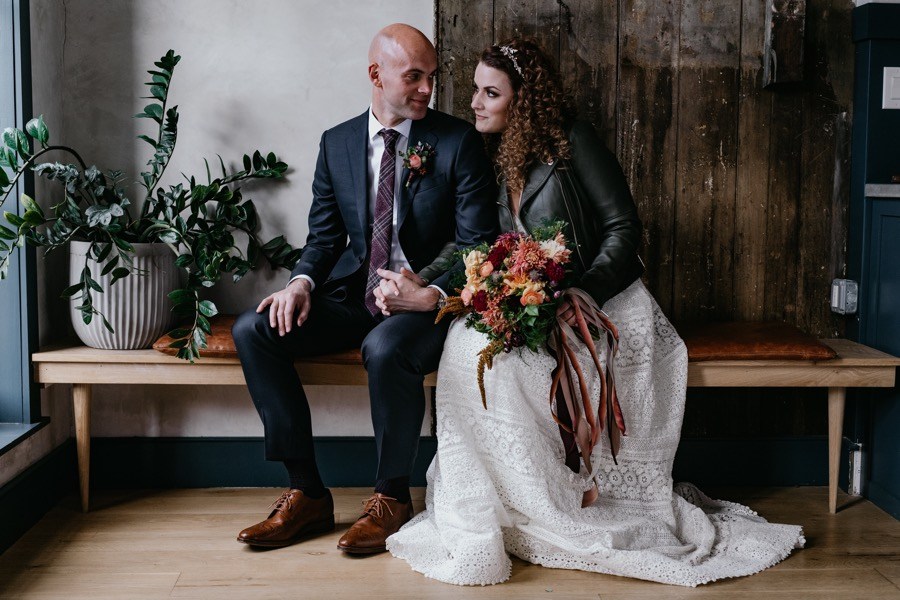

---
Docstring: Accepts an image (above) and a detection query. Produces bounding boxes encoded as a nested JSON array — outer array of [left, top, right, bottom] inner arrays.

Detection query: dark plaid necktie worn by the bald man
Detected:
[[366, 129, 400, 315]]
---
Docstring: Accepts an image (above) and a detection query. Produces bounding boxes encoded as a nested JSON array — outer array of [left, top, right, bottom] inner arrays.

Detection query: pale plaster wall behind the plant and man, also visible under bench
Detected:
[[0, 0, 434, 483]]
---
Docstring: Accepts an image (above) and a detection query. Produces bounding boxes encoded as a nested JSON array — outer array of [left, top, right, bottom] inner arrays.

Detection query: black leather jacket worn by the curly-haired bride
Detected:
[[497, 122, 644, 306]]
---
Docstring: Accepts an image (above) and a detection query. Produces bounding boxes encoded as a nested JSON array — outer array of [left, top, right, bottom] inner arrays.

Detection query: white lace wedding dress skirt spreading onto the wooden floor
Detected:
[[387, 281, 804, 586]]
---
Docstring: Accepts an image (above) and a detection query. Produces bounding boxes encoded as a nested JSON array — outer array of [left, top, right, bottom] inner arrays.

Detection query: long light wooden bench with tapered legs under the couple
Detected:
[[32, 330, 900, 513]]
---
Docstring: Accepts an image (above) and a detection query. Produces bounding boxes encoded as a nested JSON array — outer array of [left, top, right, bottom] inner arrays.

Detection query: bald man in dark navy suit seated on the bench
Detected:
[[233, 24, 498, 554]]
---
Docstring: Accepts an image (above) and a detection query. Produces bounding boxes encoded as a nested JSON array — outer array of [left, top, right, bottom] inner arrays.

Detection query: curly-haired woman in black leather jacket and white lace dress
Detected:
[[388, 39, 804, 586]]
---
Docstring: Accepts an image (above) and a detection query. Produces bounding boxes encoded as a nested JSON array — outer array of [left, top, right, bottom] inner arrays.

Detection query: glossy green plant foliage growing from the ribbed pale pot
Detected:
[[0, 50, 299, 360]]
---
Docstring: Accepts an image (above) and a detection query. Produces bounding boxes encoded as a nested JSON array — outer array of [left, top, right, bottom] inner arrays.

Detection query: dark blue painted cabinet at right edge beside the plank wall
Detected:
[[848, 4, 900, 518]]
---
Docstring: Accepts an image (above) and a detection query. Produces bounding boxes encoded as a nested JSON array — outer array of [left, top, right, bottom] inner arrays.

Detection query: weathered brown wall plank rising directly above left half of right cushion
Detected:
[[672, 0, 741, 320]]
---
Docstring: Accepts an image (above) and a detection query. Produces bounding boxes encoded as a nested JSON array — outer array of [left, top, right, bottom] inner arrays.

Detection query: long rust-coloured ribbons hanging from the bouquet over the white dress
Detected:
[[548, 288, 625, 506]]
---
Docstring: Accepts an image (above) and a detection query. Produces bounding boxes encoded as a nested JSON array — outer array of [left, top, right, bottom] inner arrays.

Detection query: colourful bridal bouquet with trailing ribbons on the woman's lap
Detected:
[[437, 221, 625, 470]]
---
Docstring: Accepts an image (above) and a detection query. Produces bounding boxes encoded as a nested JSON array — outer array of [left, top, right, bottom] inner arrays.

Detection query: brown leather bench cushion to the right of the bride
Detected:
[[678, 321, 836, 362]]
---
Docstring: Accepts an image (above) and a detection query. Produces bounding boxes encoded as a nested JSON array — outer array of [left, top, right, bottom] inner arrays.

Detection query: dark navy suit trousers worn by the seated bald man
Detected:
[[232, 293, 450, 479]]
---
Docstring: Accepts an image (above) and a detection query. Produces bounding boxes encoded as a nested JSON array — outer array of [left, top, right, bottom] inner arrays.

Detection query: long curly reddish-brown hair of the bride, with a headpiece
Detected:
[[481, 38, 575, 193]]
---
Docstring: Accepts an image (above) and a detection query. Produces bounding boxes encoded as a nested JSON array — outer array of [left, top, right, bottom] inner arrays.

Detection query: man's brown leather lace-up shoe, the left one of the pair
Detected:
[[238, 490, 334, 548]]
